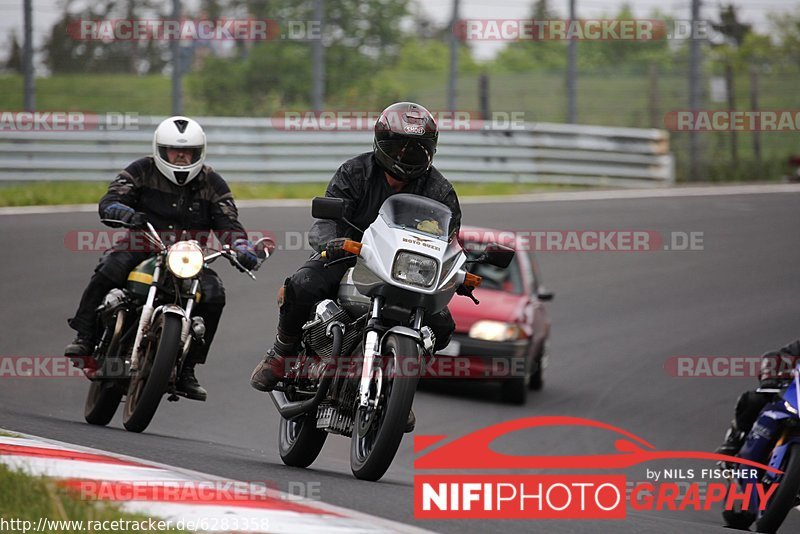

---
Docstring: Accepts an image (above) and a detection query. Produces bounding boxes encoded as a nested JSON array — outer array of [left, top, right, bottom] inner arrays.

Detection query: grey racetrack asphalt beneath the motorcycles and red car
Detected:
[[0, 193, 800, 533]]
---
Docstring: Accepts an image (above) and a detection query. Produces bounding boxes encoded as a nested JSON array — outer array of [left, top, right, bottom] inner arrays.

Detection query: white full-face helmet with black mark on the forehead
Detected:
[[153, 116, 206, 185]]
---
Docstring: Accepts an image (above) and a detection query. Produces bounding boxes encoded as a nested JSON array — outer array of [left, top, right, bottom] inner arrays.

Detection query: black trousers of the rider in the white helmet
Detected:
[[67, 250, 225, 363]]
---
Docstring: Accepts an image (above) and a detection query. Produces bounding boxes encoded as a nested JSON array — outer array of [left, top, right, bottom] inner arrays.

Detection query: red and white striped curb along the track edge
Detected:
[[0, 431, 426, 534]]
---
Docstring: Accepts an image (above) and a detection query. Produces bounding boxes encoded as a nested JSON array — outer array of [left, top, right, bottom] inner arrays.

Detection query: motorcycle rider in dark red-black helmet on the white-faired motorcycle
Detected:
[[250, 102, 461, 431]]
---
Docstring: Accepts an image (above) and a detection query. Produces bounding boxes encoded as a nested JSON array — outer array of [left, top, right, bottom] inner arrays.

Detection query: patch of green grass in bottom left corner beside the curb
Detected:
[[0, 464, 184, 534]]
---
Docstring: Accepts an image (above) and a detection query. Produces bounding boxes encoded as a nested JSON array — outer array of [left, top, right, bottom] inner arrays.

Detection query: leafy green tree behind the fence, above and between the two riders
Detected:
[[189, 0, 409, 114]]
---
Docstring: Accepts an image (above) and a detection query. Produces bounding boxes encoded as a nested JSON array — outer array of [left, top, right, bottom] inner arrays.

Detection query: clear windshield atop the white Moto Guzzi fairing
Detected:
[[378, 193, 452, 241]]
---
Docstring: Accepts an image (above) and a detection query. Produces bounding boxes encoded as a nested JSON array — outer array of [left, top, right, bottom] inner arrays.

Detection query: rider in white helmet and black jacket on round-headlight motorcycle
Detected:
[[64, 116, 258, 400]]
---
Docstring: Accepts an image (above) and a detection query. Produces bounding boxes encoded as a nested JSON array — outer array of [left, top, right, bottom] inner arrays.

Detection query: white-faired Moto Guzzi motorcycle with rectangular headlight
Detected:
[[271, 194, 514, 480]]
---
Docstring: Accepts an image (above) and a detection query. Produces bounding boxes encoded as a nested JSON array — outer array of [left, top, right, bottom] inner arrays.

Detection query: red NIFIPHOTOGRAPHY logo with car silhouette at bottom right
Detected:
[[414, 416, 780, 519]]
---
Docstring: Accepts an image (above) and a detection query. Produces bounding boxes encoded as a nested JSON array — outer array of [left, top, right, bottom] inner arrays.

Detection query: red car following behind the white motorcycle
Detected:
[[437, 227, 553, 404]]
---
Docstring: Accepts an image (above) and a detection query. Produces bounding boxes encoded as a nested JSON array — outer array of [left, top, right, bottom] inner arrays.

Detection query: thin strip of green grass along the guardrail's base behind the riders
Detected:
[[0, 181, 585, 207]]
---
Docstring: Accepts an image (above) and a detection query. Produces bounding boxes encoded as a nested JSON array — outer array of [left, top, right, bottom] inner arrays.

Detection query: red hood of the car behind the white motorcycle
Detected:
[[448, 288, 527, 333]]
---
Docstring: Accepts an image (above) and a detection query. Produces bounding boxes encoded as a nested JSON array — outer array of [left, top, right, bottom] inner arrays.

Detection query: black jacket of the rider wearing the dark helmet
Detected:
[[308, 152, 461, 251]]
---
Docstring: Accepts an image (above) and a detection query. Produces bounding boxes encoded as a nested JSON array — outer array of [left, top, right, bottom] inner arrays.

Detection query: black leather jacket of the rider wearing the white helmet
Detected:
[[99, 157, 247, 245]]
